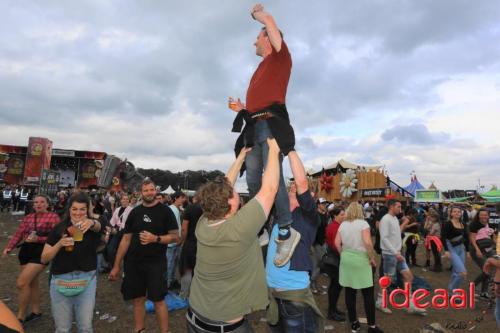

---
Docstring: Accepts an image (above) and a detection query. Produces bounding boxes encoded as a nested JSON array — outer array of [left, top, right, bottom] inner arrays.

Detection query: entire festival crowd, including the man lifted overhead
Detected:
[[2, 5, 500, 333]]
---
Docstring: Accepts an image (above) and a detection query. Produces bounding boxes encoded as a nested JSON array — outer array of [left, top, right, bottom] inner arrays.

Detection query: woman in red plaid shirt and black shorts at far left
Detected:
[[3, 195, 59, 323]]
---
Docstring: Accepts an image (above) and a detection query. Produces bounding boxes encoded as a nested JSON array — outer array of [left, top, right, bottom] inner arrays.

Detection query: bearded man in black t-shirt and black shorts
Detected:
[[109, 179, 179, 333]]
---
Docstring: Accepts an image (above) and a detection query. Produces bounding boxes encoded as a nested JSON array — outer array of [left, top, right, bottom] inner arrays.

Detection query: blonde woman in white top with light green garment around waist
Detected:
[[335, 202, 383, 333]]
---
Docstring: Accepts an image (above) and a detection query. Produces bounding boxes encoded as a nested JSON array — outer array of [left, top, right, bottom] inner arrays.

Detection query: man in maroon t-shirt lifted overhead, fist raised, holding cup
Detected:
[[228, 4, 301, 267]]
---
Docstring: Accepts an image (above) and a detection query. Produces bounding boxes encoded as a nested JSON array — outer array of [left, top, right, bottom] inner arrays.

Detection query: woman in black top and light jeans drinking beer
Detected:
[[41, 192, 101, 333]]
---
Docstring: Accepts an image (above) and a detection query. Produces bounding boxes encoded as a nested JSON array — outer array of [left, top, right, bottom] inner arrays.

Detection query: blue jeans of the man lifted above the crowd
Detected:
[[245, 121, 292, 227]]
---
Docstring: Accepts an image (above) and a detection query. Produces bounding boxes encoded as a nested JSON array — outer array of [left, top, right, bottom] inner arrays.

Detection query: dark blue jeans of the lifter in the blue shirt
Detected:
[[269, 299, 318, 333]]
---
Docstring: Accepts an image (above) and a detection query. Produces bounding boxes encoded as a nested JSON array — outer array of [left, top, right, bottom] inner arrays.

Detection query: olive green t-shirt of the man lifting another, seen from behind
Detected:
[[189, 198, 269, 321]]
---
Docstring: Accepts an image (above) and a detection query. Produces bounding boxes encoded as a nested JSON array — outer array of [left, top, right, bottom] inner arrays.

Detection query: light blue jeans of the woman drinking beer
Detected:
[[50, 271, 97, 333]]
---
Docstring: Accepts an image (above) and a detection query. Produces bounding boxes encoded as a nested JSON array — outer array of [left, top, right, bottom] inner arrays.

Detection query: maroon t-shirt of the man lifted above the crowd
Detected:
[[246, 41, 292, 113]]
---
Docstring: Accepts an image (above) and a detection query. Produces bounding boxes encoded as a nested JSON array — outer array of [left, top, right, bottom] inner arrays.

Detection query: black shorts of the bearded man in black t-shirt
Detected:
[[121, 257, 168, 302]]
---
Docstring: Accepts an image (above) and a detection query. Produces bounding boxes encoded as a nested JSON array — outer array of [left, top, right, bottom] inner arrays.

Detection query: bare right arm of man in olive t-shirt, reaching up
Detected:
[[255, 139, 280, 216]]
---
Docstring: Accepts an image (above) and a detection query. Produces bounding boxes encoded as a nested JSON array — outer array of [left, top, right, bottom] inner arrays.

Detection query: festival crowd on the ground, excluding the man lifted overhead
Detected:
[[3, 182, 500, 332]]
